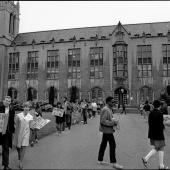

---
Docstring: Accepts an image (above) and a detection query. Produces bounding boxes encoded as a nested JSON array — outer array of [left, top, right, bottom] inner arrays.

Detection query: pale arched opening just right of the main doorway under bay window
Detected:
[[139, 86, 153, 102]]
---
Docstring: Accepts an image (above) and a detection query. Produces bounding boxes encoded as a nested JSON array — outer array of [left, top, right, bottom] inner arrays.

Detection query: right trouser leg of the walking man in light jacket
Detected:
[[108, 134, 116, 163]]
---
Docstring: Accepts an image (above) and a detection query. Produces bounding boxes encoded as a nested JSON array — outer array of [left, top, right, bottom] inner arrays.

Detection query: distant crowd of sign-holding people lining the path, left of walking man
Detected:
[[54, 97, 104, 135]]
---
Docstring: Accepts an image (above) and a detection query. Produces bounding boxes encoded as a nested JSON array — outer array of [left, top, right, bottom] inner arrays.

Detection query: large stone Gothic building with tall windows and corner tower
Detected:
[[0, 1, 170, 105]]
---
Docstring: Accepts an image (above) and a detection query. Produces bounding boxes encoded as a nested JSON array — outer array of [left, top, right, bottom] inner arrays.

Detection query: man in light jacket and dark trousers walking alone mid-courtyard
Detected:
[[98, 96, 123, 169]]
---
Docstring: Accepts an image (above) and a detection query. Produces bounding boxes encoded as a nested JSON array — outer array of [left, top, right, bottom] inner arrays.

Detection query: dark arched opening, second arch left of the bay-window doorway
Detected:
[[68, 86, 80, 103]]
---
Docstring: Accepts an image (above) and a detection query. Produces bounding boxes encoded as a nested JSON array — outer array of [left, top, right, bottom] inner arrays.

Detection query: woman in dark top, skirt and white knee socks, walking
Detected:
[[142, 100, 168, 169]]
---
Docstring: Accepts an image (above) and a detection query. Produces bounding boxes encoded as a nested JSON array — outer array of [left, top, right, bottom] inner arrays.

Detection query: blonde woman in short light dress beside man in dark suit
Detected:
[[13, 102, 33, 169]]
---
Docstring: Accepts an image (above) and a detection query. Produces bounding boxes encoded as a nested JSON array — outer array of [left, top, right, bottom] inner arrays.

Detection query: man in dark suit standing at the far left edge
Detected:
[[0, 96, 15, 169]]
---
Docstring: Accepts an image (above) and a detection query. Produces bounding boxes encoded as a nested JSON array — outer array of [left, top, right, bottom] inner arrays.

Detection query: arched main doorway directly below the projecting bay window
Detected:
[[114, 87, 127, 105]]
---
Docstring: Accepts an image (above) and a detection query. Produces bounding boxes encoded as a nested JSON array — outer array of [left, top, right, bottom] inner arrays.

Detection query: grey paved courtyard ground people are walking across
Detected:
[[0, 114, 170, 169]]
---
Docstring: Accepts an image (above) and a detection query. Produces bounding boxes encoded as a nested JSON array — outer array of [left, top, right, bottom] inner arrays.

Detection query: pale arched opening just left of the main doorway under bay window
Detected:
[[91, 87, 103, 102]]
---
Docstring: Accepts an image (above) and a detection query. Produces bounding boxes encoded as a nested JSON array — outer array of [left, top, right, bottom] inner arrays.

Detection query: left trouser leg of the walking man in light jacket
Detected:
[[98, 133, 107, 161]]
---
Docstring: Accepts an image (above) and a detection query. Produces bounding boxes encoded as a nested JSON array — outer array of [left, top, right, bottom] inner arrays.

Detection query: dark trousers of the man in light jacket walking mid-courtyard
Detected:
[[98, 133, 116, 163]]
